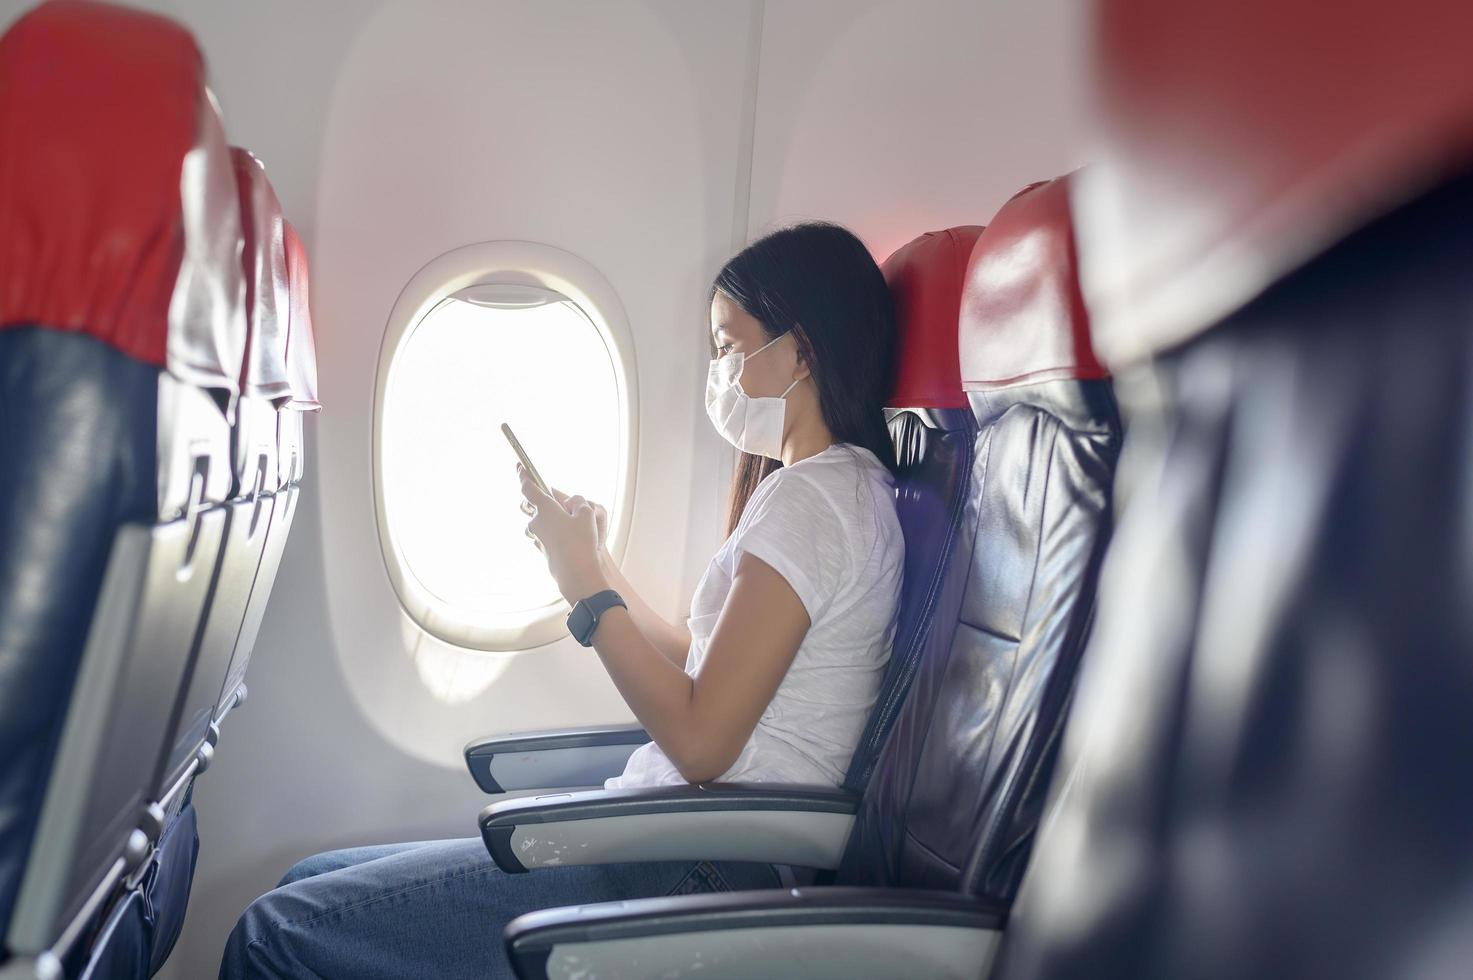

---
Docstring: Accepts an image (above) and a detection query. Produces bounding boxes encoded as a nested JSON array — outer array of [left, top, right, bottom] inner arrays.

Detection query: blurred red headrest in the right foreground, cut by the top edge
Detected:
[[1075, 0, 1473, 365]]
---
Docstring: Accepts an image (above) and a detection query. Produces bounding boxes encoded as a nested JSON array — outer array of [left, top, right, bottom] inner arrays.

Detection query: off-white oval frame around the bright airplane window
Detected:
[[371, 242, 639, 653]]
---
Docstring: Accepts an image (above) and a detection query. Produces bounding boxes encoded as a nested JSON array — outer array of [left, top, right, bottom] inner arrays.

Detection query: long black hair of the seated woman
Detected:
[[707, 221, 896, 533]]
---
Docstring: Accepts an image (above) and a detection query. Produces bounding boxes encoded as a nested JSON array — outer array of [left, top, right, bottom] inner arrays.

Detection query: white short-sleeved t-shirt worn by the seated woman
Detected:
[[604, 444, 904, 790]]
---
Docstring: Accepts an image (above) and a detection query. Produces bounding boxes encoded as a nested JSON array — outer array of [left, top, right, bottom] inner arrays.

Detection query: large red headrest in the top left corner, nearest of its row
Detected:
[[0, 0, 245, 393]]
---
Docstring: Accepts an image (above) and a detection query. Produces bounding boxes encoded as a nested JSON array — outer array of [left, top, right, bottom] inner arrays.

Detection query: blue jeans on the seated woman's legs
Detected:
[[219, 837, 779, 980]]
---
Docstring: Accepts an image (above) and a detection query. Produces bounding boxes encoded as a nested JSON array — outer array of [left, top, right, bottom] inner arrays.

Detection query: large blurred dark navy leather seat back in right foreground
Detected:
[[1006, 162, 1473, 977]]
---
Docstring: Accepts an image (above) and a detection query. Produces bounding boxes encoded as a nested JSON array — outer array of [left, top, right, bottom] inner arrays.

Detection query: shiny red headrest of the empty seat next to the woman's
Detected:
[[960, 177, 1109, 391]]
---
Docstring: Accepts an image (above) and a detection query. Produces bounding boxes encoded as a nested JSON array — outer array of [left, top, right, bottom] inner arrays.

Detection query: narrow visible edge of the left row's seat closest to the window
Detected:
[[215, 221, 321, 725]]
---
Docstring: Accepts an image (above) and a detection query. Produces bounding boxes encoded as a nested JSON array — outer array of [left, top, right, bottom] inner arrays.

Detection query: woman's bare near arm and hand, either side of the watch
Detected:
[[518, 467, 809, 783]]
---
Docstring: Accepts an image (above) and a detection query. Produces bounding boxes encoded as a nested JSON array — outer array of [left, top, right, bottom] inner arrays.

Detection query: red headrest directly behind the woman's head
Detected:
[[881, 225, 982, 408]]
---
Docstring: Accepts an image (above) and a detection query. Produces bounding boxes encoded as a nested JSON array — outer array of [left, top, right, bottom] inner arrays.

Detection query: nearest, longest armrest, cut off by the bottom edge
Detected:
[[504, 887, 1008, 980]]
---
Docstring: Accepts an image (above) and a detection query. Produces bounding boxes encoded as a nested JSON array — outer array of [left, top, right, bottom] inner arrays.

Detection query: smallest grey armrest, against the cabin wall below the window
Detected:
[[465, 725, 650, 793]]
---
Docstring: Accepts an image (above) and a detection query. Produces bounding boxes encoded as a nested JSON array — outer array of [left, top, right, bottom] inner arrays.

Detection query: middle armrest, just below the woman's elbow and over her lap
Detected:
[[480, 783, 859, 874]]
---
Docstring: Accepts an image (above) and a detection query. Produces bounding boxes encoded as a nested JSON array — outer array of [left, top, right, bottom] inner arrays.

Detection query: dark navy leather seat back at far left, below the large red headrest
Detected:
[[0, 326, 158, 943]]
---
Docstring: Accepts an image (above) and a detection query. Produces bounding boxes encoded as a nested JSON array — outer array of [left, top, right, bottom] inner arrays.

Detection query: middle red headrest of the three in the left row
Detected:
[[230, 146, 292, 401]]
